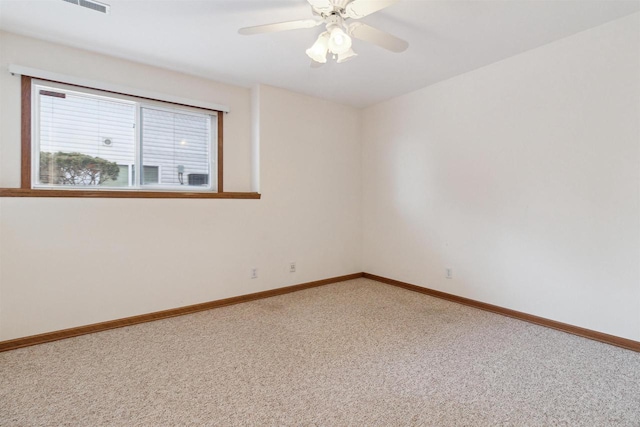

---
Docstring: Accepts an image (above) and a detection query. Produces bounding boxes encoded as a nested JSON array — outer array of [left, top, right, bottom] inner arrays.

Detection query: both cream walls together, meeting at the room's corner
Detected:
[[0, 14, 640, 340]]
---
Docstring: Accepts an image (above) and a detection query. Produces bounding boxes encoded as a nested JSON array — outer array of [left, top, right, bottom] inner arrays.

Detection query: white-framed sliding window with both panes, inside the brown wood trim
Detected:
[[31, 80, 218, 192]]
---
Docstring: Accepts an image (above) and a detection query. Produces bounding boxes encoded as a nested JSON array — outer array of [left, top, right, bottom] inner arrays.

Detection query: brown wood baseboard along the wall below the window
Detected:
[[0, 273, 363, 352]]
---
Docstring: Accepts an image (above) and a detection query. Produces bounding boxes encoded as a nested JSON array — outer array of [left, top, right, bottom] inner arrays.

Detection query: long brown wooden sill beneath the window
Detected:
[[0, 188, 260, 199]]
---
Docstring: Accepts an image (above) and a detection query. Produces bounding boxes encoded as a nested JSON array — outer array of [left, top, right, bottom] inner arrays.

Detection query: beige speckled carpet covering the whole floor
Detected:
[[0, 279, 640, 426]]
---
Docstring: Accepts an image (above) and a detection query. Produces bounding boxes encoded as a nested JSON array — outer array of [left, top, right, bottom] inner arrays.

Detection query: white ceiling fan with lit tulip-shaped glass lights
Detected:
[[238, 0, 409, 66]]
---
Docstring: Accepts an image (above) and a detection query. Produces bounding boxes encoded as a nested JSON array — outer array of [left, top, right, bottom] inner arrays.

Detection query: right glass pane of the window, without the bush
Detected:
[[141, 107, 211, 186]]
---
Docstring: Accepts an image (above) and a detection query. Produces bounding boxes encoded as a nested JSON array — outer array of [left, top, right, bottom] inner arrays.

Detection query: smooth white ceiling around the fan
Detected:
[[0, 0, 640, 107]]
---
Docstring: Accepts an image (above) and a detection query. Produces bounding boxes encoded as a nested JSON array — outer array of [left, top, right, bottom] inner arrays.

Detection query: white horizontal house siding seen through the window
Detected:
[[37, 88, 213, 187]]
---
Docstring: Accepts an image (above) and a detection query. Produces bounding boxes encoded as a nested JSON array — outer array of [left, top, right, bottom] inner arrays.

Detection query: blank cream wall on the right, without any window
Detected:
[[362, 14, 640, 340]]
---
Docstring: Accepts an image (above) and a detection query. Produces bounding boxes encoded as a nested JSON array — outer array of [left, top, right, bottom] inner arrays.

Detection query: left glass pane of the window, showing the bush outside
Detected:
[[35, 86, 136, 187]]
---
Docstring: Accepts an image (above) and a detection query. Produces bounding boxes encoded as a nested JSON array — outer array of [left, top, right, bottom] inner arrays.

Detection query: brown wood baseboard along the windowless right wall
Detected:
[[363, 273, 640, 352]]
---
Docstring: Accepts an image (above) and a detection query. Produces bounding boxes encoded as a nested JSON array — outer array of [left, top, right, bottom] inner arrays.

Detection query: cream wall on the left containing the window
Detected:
[[0, 32, 362, 340]]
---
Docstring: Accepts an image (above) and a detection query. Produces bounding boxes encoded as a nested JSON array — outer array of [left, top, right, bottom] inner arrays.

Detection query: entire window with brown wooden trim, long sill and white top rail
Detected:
[[0, 72, 261, 199]]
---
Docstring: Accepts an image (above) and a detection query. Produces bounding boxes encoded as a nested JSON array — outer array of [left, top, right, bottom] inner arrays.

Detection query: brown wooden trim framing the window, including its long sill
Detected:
[[0, 75, 260, 199]]
